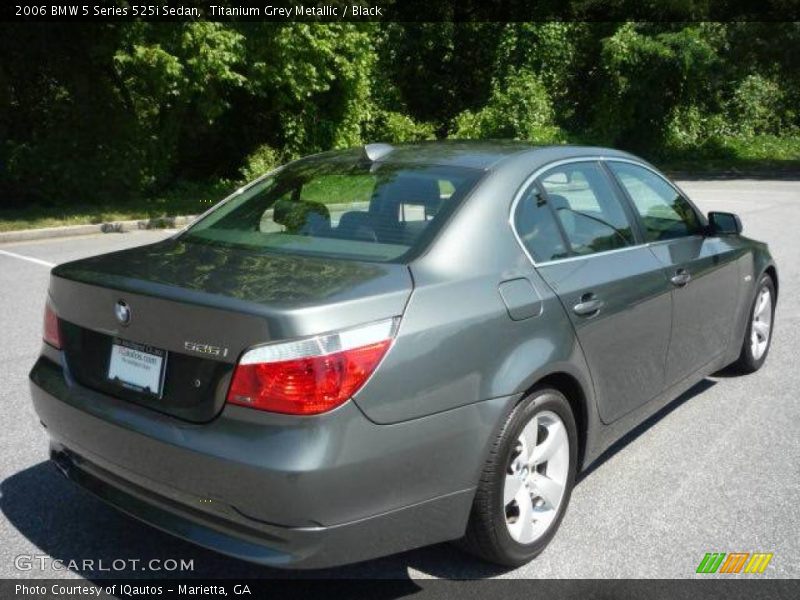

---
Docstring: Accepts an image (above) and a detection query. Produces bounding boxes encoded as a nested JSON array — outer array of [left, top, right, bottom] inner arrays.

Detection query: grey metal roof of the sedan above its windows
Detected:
[[301, 140, 645, 170]]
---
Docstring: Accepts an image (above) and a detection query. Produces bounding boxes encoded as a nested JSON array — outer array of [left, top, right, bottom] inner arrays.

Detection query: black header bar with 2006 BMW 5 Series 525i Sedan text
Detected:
[[0, 0, 800, 23]]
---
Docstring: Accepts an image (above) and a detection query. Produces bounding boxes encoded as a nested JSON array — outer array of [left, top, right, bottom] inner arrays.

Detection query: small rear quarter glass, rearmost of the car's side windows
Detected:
[[514, 186, 568, 262]]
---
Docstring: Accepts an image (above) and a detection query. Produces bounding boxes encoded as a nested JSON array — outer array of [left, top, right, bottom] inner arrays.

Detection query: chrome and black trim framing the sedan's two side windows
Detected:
[[508, 155, 706, 268]]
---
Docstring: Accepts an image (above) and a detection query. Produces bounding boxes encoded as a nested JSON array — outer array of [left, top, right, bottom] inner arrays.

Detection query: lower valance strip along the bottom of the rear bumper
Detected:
[[50, 443, 472, 569]]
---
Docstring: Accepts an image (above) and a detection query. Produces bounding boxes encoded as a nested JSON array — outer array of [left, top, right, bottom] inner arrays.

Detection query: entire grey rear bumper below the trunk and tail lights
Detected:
[[31, 357, 509, 568]]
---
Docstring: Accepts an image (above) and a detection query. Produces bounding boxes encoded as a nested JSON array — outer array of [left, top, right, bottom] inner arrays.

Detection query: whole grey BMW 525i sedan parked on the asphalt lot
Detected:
[[30, 142, 778, 568]]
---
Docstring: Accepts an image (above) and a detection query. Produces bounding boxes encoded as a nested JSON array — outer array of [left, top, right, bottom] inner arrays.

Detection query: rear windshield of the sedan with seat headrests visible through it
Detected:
[[181, 162, 481, 262]]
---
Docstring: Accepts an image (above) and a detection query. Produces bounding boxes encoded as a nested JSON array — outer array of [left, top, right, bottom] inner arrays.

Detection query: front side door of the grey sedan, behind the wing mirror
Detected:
[[607, 160, 739, 385]]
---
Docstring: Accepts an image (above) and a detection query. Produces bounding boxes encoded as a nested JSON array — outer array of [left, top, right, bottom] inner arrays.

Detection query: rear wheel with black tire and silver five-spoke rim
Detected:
[[460, 388, 578, 567]]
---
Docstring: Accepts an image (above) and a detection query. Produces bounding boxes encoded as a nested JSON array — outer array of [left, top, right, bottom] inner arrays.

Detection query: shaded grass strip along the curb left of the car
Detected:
[[0, 180, 236, 231]]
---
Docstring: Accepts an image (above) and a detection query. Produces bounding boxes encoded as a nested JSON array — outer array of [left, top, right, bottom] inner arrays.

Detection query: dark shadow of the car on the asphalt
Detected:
[[0, 379, 715, 580]]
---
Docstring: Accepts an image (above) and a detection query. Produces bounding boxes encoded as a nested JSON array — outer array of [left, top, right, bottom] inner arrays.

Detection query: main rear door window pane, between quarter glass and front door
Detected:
[[539, 162, 634, 254]]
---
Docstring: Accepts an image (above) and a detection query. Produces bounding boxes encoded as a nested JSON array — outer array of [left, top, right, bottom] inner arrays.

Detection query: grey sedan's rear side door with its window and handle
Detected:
[[516, 161, 671, 423]]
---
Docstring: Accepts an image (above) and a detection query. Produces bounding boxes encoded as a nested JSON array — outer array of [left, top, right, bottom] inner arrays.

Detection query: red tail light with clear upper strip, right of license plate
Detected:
[[228, 319, 399, 415]]
